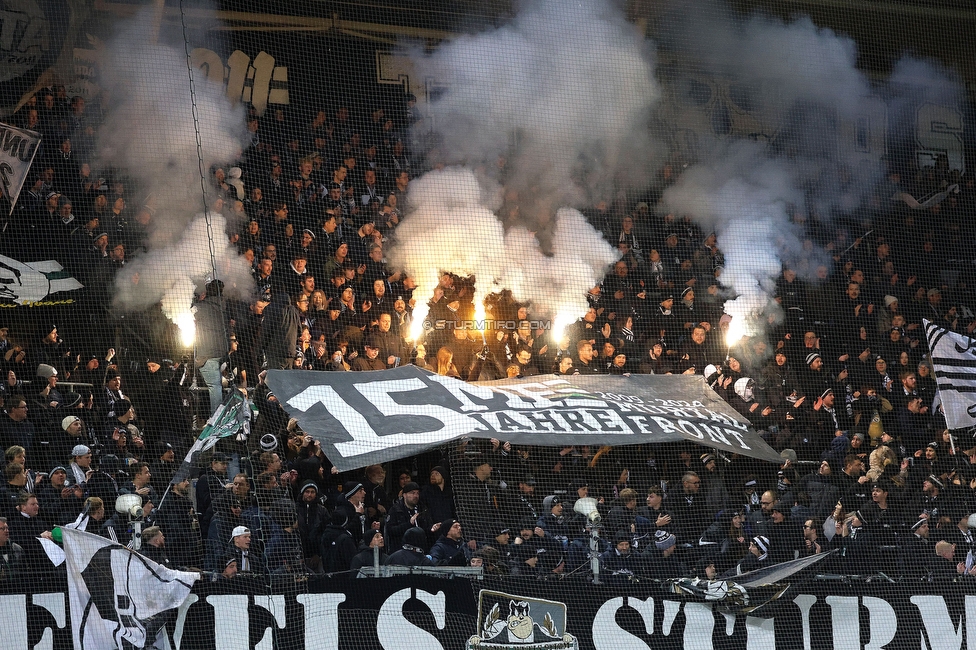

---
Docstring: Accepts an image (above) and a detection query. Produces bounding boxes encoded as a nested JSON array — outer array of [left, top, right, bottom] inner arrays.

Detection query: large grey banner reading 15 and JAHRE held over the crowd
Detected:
[[267, 365, 782, 471]]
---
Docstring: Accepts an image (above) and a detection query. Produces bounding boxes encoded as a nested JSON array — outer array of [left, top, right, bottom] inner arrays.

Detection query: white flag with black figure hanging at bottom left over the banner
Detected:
[[61, 528, 200, 650]]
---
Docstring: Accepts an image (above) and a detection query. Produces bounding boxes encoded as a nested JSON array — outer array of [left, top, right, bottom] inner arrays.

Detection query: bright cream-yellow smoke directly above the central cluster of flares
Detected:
[[390, 167, 616, 334]]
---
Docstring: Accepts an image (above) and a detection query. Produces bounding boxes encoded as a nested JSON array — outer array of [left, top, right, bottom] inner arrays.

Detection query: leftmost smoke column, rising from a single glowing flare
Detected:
[[98, 15, 251, 340]]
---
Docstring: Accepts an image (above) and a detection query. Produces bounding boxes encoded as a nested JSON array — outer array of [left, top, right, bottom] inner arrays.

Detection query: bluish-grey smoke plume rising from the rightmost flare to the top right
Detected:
[[664, 11, 958, 342]]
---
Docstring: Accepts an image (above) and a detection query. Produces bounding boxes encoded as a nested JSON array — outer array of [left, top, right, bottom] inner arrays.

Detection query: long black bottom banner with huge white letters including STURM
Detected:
[[0, 576, 976, 650]]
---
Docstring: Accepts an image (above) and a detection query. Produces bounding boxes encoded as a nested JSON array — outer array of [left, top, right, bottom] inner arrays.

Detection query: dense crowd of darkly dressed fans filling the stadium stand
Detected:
[[0, 83, 976, 579]]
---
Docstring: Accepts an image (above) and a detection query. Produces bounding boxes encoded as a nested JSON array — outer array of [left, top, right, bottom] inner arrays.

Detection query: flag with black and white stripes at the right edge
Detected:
[[924, 320, 976, 429]]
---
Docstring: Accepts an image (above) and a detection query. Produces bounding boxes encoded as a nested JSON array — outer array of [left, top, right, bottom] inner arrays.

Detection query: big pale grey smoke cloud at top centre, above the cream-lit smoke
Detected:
[[415, 0, 660, 228]]
